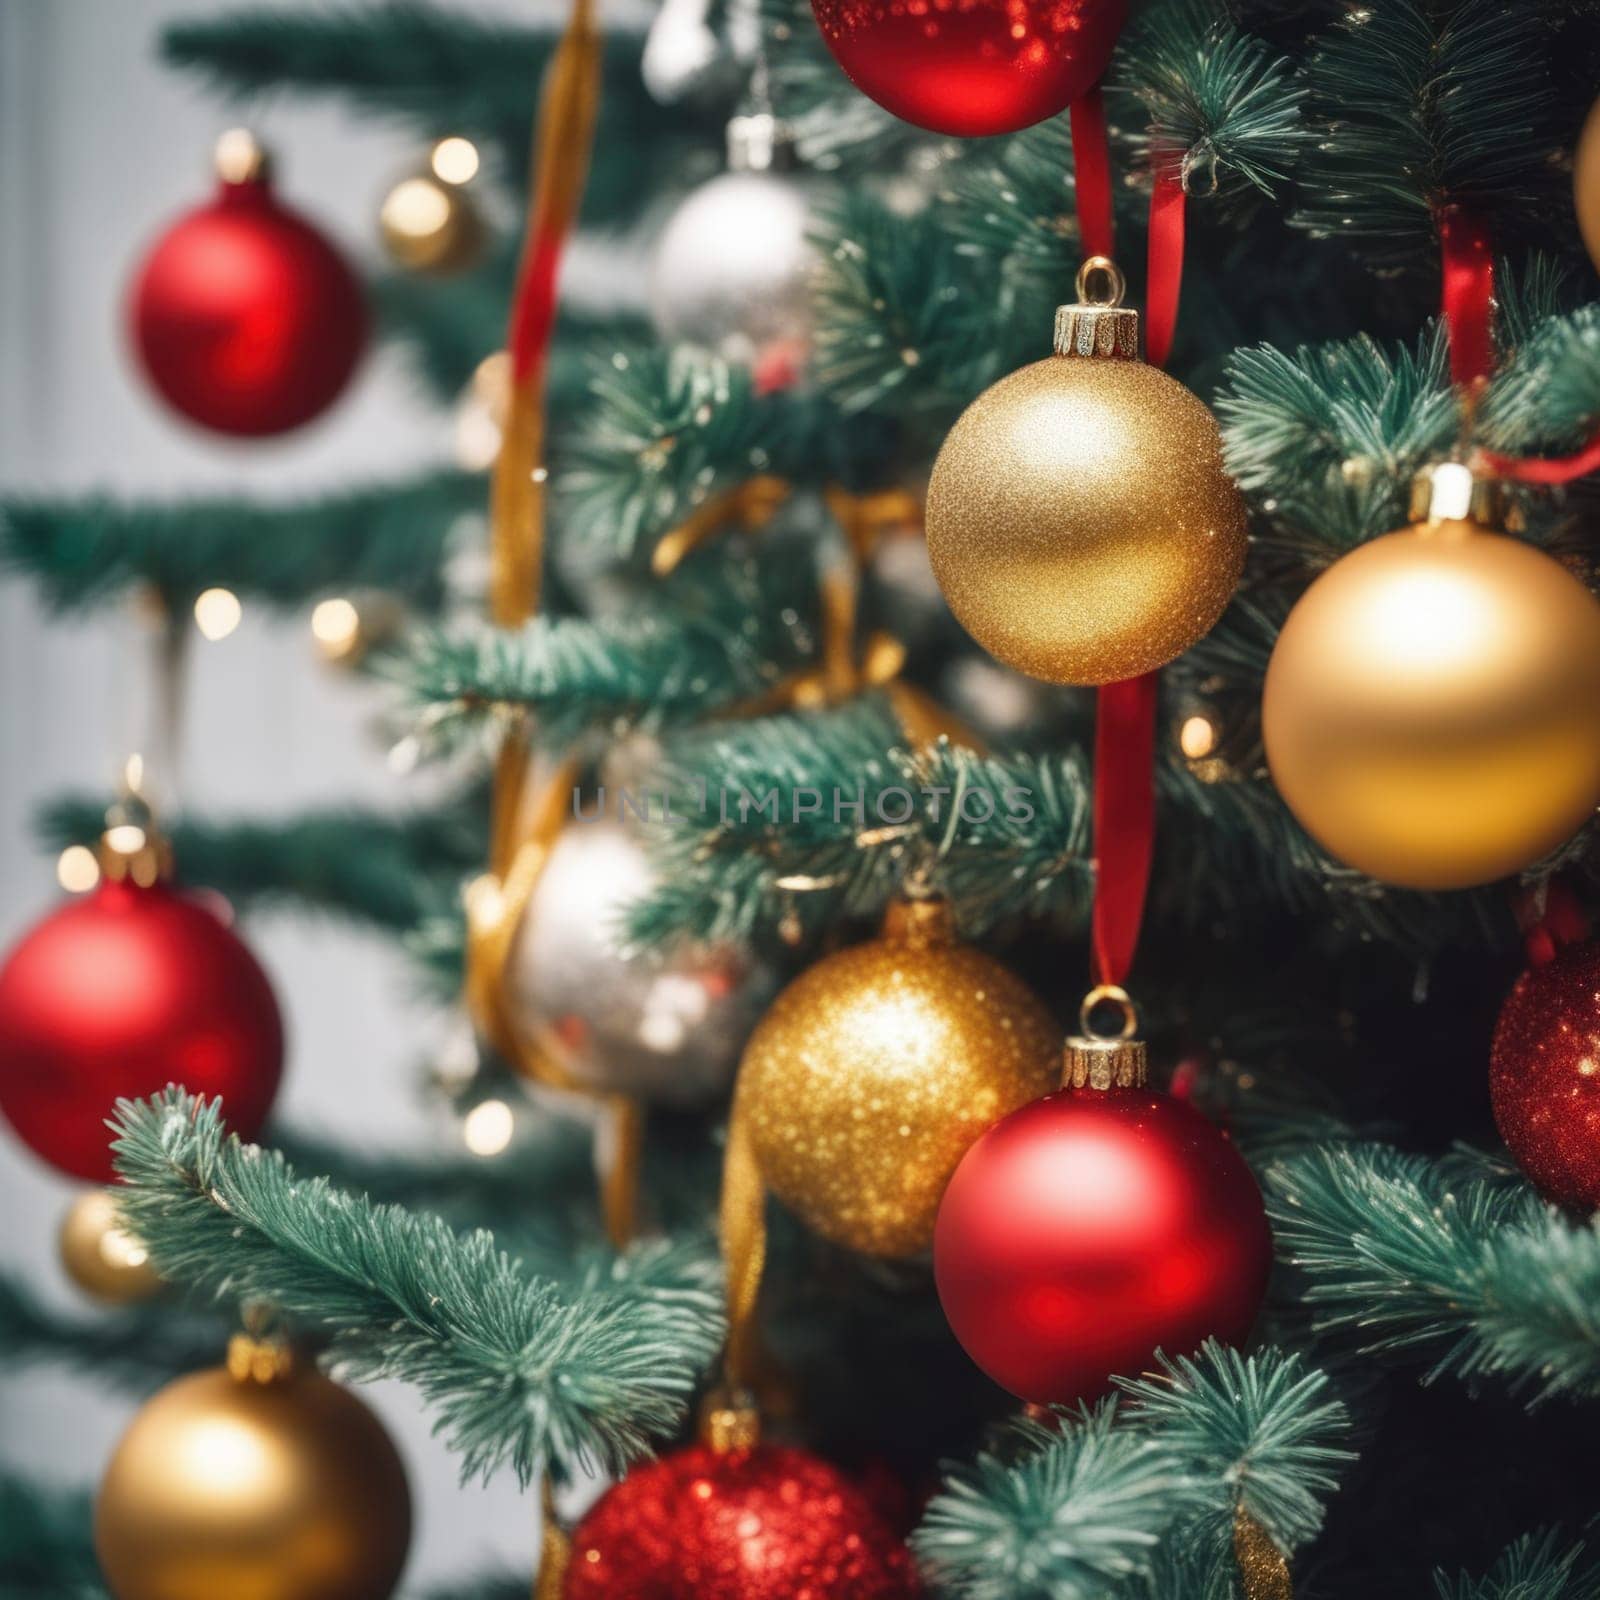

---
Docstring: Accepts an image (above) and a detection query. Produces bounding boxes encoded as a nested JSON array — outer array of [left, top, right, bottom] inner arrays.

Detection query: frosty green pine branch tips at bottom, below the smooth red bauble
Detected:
[[912, 1344, 1354, 1600]]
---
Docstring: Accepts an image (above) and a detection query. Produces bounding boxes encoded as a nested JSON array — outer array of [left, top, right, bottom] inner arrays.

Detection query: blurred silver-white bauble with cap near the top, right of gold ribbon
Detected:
[[650, 114, 813, 371]]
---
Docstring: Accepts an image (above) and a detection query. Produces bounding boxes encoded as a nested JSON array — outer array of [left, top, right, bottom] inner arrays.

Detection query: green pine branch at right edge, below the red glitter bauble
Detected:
[[1266, 1144, 1600, 1400]]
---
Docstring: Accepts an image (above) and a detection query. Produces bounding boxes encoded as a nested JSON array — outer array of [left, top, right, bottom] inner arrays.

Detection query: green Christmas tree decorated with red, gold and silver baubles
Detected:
[[9, 0, 1600, 1600]]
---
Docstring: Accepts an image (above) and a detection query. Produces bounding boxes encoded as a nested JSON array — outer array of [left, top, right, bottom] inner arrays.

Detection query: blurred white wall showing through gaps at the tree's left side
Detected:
[[0, 0, 595, 1584]]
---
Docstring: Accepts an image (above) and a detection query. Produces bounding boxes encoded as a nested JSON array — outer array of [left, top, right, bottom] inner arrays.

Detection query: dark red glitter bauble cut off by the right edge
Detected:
[[1490, 942, 1600, 1211]]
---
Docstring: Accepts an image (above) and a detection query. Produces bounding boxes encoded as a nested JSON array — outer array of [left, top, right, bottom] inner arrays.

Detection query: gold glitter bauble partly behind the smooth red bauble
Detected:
[[734, 902, 1061, 1256]]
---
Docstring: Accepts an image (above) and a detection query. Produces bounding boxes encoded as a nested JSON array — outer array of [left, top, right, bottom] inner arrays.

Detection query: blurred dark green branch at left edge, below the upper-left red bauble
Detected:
[[0, 472, 485, 611]]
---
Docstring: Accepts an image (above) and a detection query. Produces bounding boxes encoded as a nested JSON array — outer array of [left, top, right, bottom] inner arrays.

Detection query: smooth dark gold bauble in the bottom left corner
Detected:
[[94, 1368, 411, 1600]]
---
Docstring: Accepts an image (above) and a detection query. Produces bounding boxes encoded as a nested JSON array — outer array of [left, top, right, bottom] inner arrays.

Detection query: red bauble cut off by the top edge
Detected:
[[811, 0, 1128, 136]]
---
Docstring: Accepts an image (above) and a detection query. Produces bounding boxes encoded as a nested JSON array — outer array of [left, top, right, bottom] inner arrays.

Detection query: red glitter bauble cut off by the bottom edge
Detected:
[[565, 1445, 920, 1600]]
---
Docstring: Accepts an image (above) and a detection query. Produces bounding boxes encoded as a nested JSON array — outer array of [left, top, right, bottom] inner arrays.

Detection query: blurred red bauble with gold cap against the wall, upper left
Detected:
[[130, 130, 366, 435]]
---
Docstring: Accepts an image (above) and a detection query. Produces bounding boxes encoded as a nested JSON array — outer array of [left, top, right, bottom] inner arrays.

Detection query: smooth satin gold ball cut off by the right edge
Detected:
[[1262, 522, 1600, 890]]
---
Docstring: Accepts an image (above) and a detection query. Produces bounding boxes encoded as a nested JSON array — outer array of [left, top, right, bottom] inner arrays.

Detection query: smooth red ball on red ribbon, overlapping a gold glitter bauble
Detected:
[[933, 1088, 1272, 1403]]
